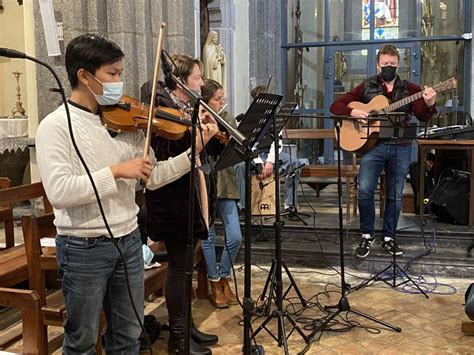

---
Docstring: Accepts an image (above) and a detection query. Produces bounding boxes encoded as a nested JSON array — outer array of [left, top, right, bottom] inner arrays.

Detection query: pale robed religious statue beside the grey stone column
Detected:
[[202, 31, 226, 92]]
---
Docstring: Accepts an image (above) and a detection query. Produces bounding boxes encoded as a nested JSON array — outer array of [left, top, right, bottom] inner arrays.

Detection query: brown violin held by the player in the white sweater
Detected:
[[100, 95, 191, 140]]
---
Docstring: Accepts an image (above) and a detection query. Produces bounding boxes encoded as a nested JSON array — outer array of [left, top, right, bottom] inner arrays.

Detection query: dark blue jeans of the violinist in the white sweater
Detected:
[[56, 229, 144, 354]]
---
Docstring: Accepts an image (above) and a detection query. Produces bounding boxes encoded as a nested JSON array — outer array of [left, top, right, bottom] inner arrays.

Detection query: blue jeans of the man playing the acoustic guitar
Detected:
[[359, 143, 411, 238]]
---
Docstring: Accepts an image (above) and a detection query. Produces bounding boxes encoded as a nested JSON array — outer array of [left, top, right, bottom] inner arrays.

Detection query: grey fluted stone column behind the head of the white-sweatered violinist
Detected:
[[34, 0, 195, 120]]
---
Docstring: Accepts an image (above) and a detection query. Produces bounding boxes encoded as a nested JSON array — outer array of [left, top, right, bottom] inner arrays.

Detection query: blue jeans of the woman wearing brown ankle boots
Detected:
[[201, 199, 242, 280]]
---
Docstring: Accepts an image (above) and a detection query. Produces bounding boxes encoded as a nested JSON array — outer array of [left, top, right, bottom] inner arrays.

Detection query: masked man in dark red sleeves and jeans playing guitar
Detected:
[[330, 44, 436, 258]]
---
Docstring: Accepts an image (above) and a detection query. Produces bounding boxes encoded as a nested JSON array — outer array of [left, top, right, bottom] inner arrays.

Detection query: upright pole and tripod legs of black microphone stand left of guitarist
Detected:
[[308, 121, 402, 350]]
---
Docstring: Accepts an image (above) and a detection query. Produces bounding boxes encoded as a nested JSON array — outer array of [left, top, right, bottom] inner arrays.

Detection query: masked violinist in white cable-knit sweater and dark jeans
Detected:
[[36, 34, 217, 354]]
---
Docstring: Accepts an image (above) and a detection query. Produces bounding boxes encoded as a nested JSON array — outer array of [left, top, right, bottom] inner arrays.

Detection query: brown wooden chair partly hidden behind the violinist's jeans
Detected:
[[21, 213, 104, 354]]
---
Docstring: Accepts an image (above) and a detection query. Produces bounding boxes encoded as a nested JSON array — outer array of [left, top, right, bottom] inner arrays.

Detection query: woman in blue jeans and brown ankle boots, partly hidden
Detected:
[[201, 79, 242, 308]]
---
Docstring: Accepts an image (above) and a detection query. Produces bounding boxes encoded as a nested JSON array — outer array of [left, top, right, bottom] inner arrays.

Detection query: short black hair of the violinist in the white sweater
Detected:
[[66, 33, 124, 89]]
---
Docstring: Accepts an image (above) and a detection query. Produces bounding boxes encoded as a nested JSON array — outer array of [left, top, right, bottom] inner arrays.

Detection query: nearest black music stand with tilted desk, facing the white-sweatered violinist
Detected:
[[214, 93, 283, 355]]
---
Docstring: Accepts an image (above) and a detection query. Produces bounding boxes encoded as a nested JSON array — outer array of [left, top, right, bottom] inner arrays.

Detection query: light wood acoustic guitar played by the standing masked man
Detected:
[[340, 78, 457, 153]]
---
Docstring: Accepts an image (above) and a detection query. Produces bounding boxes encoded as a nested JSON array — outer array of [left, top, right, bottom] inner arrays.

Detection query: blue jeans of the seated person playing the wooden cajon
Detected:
[[234, 152, 301, 209]]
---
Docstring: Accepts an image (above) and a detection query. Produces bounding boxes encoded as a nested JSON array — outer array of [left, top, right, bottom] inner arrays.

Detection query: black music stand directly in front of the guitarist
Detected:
[[360, 112, 429, 298]]
